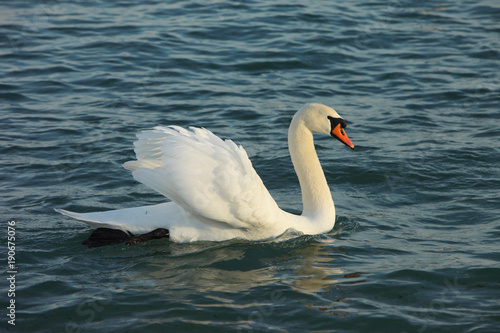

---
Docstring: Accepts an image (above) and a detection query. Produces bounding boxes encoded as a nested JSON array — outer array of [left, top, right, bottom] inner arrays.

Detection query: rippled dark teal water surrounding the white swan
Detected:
[[0, 0, 500, 333]]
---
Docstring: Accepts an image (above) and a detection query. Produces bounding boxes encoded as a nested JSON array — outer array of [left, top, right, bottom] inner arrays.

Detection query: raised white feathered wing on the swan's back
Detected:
[[124, 126, 279, 229]]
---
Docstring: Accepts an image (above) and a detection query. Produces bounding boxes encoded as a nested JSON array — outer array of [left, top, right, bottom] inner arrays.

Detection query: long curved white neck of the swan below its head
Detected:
[[288, 114, 335, 220]]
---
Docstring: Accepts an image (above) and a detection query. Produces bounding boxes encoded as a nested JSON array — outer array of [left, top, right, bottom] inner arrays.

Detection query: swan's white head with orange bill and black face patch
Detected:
[[297, 103, 354, 149]]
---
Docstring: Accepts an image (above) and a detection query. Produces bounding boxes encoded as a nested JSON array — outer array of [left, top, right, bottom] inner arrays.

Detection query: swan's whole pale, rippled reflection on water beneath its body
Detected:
[[128, 236, 358, 296]]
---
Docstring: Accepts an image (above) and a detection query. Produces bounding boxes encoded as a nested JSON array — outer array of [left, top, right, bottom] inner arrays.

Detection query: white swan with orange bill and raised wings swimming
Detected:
[[56, 103, 354, 246]]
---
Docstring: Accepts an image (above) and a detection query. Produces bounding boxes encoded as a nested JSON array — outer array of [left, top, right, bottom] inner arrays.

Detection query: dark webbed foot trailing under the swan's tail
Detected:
[[82, 228, 170, 248]]
